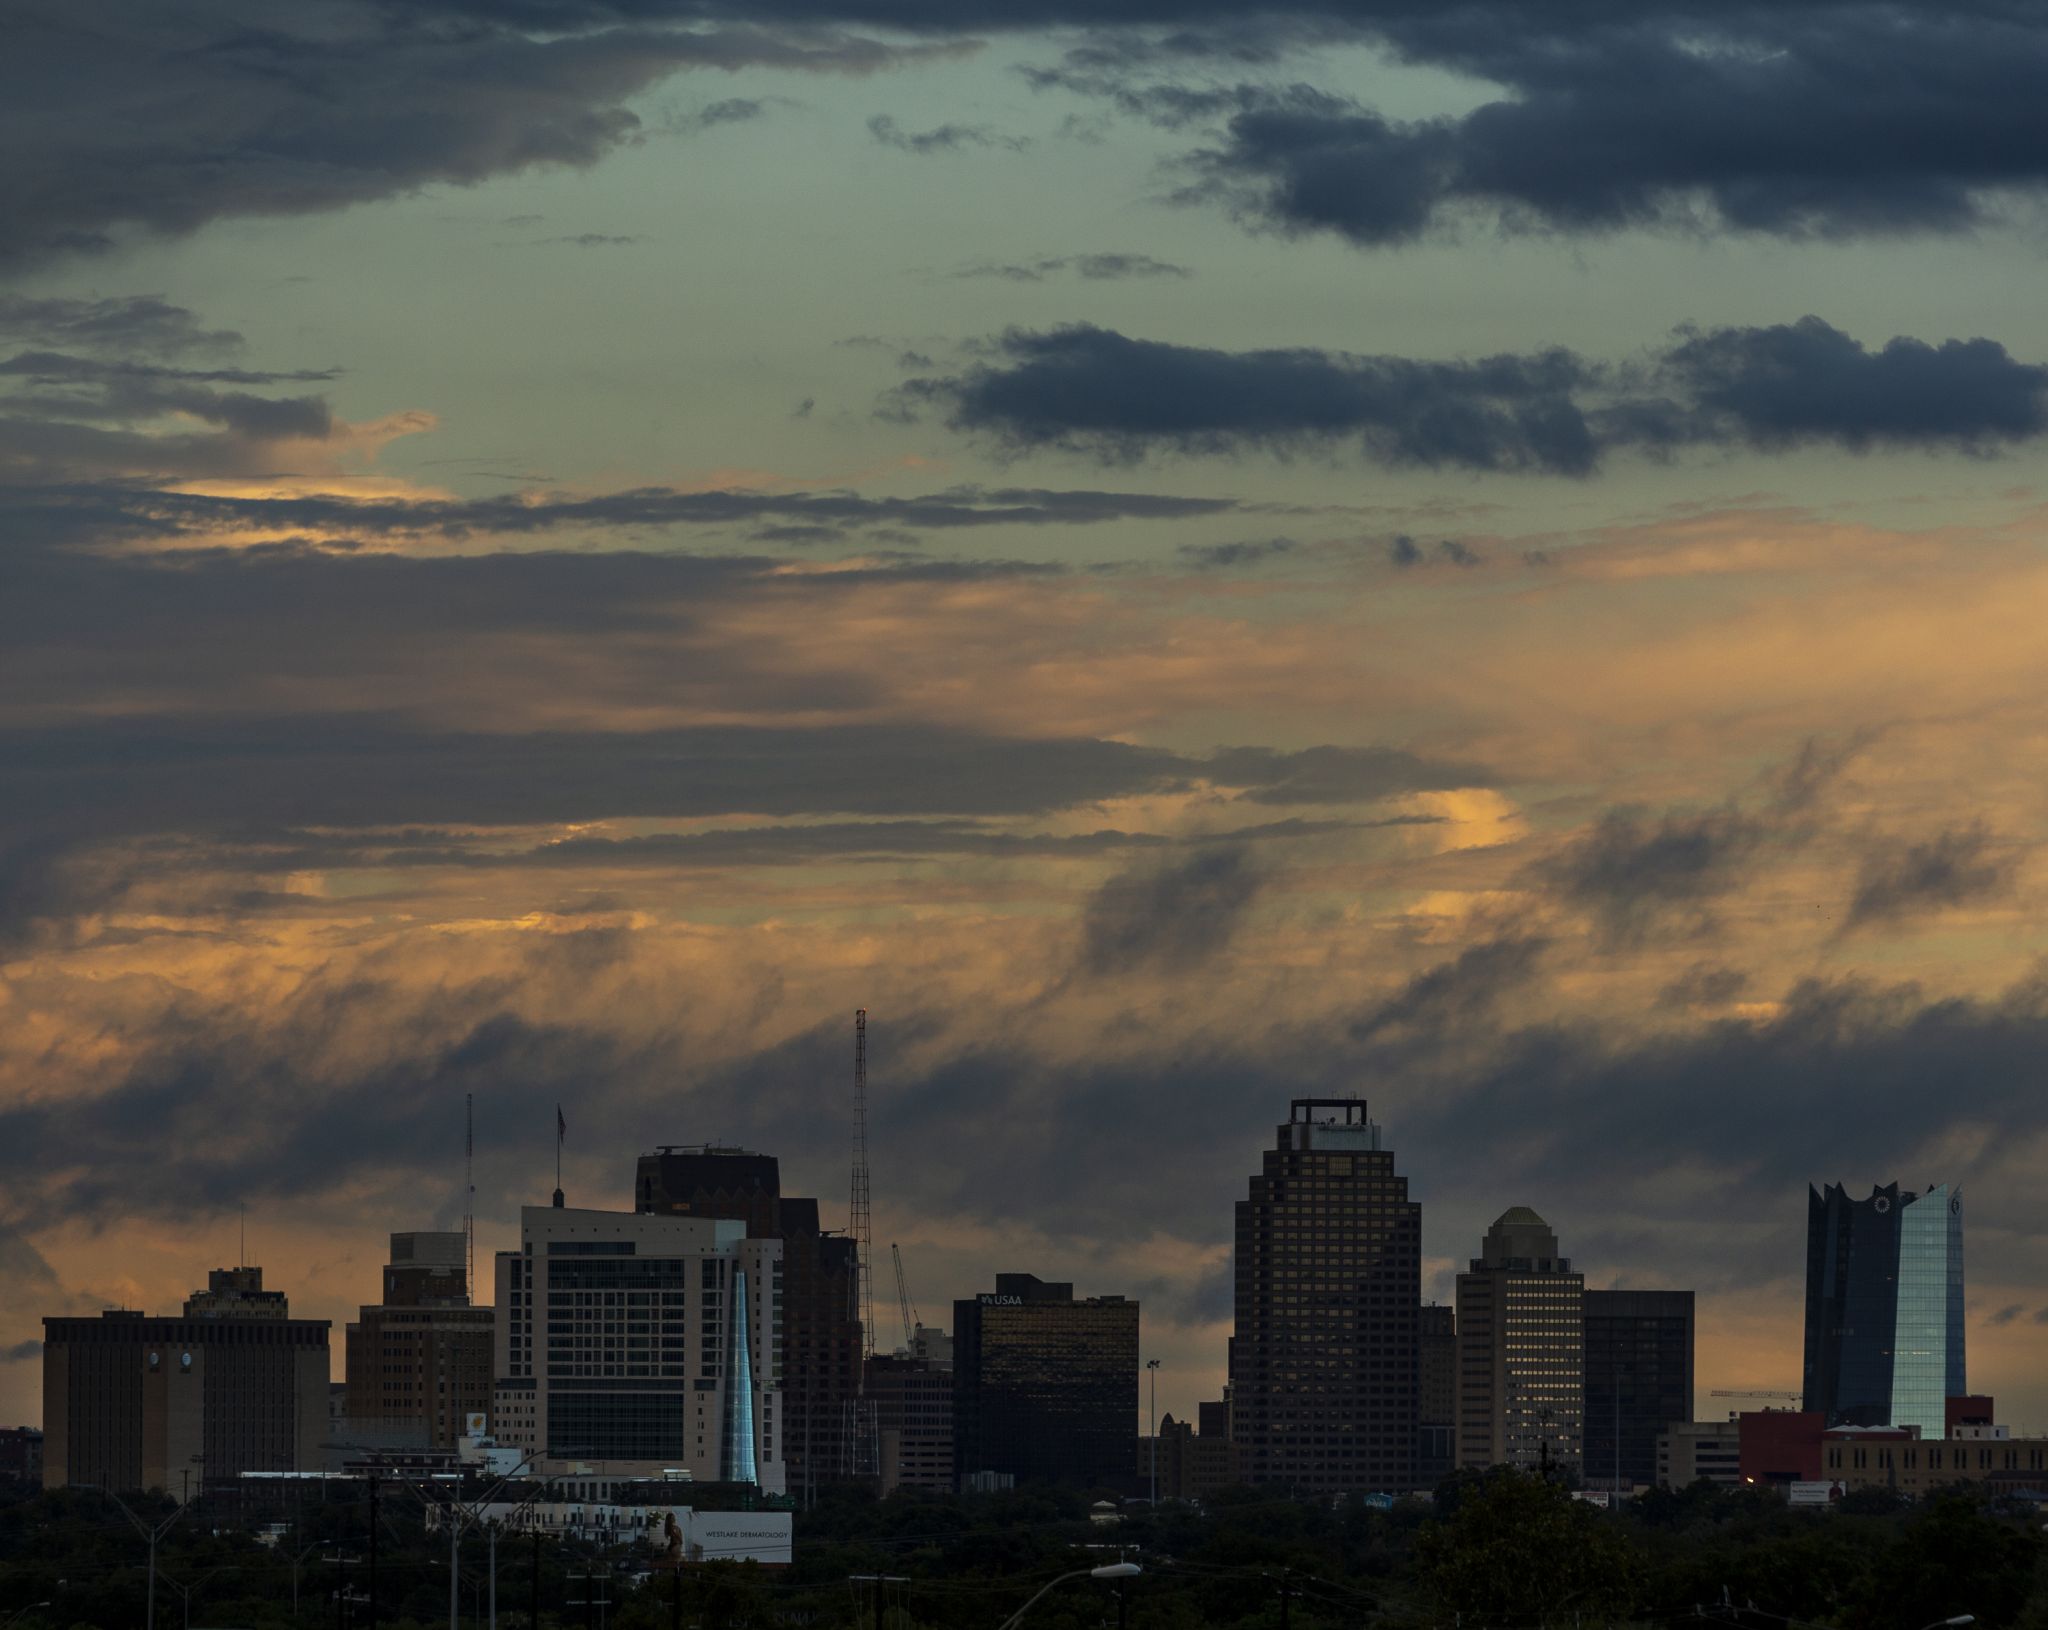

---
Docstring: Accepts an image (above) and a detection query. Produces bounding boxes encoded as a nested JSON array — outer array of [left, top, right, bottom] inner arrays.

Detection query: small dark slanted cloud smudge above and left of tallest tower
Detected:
[[1081, 844, 1264, 979]]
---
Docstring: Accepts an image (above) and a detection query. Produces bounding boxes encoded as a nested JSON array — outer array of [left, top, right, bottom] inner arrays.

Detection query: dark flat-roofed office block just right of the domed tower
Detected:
[[1583, 1290, 1692, 1493]]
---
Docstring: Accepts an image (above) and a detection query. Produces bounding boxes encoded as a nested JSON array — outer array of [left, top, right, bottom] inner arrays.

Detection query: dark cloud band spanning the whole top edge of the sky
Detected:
[[0, 0, 2048, 262]]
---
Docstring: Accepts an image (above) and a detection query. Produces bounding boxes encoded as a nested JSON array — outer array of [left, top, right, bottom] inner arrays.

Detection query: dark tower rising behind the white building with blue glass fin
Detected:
[[633, 1143, 862, 1495]]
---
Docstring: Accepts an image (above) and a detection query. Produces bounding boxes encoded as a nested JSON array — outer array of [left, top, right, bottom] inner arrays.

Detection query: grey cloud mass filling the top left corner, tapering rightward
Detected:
[[0, 0, 950, 264]]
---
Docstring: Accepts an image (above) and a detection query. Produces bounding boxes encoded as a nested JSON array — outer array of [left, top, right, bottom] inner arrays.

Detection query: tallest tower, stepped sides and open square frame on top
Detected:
[[1231, 1098, 1421, 1493]]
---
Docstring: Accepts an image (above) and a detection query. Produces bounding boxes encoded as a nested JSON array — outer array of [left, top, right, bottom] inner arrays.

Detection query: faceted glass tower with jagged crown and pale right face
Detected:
[[1804, 1184, 1970, 1438]]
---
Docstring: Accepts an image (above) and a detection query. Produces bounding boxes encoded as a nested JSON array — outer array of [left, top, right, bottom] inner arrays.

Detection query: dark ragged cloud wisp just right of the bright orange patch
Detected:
[[1534, 807, 1767, 946]]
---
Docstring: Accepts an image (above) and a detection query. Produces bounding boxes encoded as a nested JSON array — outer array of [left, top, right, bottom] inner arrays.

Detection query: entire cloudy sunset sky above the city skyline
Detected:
[[0, 0, 2048, 1429]]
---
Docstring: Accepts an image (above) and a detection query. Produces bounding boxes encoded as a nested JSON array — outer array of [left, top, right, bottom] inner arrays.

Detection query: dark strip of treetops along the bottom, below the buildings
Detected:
[[0, 1472, 2048, 1630]]
